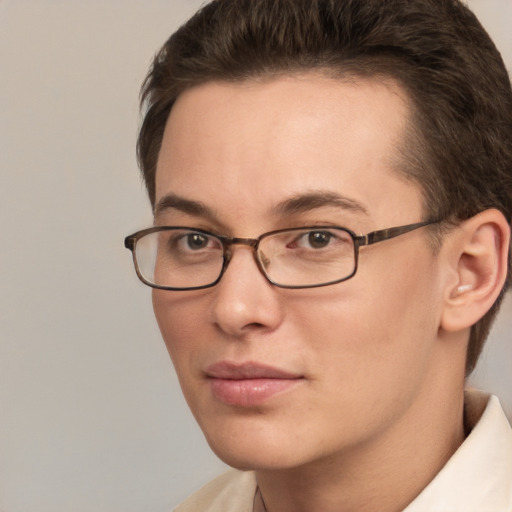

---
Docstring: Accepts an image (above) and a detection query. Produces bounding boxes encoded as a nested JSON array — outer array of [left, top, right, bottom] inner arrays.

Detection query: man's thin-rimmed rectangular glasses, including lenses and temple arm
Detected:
[[124, 221, 439, 290]]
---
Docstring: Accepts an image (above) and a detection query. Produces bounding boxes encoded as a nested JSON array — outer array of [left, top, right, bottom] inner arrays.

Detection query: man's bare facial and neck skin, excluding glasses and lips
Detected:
[[153, 74, 468, 512]]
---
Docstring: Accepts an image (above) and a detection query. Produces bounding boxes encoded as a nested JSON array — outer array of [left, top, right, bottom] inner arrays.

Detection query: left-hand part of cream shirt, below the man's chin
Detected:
[[175, 470, 256, 512]]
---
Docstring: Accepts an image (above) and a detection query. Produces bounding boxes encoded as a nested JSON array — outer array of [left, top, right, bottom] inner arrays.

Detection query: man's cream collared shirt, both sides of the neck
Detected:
[[175, 391, 512, 512]]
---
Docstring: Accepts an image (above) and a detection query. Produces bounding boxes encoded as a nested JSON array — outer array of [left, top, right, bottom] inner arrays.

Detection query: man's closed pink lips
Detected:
[[206, 361, 302, 407]]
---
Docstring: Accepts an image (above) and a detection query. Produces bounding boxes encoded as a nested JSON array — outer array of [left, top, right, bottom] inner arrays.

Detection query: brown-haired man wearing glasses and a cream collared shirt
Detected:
[[125, 0, 512, 512]]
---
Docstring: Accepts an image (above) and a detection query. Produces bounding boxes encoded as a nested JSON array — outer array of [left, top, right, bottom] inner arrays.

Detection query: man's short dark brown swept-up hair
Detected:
[[137, 0, 512, 374]]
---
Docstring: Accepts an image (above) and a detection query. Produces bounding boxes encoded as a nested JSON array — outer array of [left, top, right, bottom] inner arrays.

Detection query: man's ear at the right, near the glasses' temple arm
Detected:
[[441, 209, 510, 331]]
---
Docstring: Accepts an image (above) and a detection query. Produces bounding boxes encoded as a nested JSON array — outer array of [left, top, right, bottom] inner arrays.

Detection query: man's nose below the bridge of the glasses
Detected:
[[212, 245, 283, 338]]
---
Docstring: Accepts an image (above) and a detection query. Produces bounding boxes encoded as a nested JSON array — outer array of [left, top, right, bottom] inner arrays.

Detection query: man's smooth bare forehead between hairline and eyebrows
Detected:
[[156, 74, 419, 228]]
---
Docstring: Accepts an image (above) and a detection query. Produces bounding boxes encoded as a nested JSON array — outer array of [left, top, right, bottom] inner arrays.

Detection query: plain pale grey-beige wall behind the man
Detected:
[[0, 0, 512, 512]]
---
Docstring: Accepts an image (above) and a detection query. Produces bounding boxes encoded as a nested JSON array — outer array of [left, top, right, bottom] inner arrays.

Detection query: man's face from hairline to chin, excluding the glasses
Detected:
[[153, 75, 446, 469]]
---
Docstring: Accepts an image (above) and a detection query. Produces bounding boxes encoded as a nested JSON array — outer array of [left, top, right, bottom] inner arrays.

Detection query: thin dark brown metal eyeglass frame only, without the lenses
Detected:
[[124, 220, 441, 291]]
